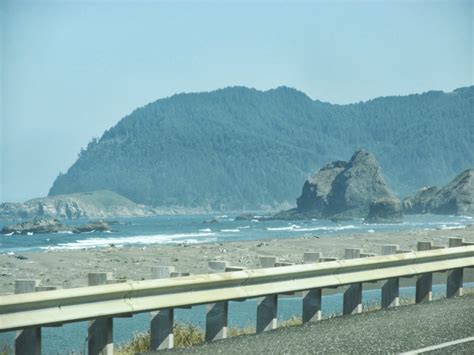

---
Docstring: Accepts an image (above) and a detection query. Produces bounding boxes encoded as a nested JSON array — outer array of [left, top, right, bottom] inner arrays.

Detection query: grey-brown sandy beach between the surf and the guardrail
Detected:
[[0, 225, 474, 294]]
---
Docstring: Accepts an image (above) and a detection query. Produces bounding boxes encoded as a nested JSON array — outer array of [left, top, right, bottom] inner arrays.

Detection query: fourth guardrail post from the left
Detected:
[[206, 261, 229, 341]]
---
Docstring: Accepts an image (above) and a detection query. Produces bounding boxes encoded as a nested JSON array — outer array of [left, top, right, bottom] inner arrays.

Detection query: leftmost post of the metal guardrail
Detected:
[[15, 280, 41, 355]]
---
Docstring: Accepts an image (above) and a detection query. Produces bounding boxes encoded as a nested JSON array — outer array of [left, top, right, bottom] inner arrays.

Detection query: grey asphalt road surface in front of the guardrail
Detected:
[[162, 296, 474, 355]]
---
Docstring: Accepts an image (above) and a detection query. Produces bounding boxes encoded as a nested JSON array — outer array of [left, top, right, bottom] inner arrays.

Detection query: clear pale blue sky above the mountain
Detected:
[[0, 0, 474, 202]]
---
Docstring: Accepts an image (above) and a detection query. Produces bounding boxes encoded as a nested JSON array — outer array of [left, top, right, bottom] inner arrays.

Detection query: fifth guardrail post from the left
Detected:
[[257, 256, 278, 333]]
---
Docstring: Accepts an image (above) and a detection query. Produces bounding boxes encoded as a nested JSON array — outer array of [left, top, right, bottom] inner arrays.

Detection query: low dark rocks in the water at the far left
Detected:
[[0, 218, 110, 235]]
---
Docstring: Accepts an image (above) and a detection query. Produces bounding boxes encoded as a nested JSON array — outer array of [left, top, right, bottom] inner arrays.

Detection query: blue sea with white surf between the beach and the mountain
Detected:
[[0, 215, 468, 254]]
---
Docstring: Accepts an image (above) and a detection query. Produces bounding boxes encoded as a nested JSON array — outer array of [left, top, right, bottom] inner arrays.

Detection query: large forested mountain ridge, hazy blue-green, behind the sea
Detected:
[[49, 86, 474, 210]]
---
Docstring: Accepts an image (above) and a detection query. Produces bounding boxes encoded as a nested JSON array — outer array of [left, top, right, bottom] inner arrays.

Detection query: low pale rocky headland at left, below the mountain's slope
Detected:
[[0, 190, 154, 220]]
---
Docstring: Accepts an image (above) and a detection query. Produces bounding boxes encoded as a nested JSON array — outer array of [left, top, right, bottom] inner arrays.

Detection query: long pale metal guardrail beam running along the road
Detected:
[[0, 246, 474, 331]]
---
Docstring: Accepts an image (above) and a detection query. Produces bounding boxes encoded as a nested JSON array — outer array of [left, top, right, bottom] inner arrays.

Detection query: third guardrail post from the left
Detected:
[[150, 266, 174, 351]]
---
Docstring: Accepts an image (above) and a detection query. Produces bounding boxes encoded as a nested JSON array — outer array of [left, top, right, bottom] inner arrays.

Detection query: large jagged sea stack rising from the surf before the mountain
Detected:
[[273, 150, 400, 219]]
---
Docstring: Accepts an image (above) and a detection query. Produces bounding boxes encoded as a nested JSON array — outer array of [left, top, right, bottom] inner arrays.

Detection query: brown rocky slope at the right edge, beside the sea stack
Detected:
[[403, 168, 474, 215]]
